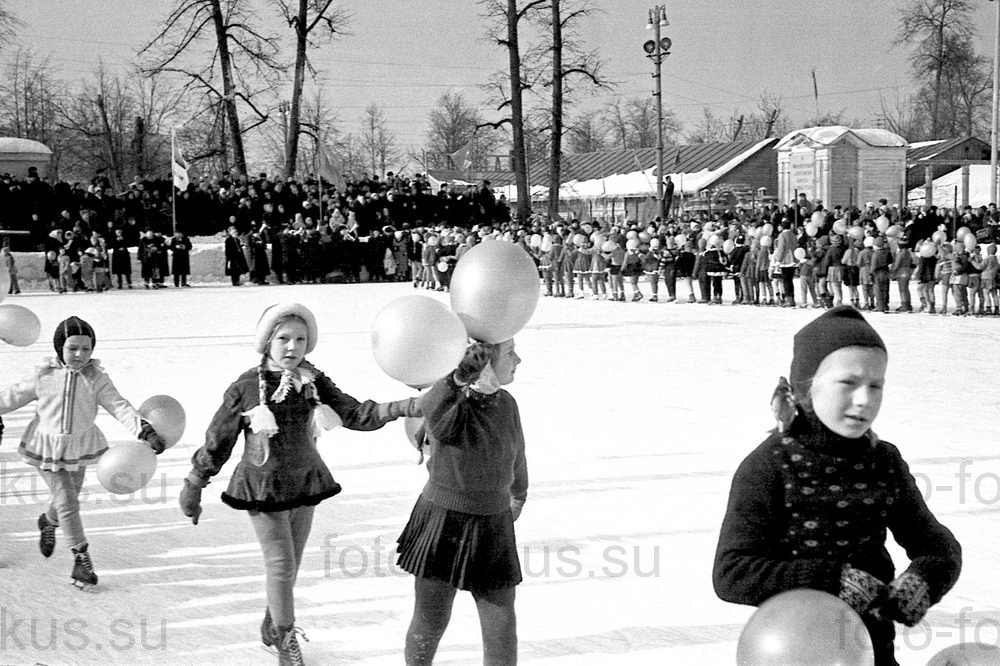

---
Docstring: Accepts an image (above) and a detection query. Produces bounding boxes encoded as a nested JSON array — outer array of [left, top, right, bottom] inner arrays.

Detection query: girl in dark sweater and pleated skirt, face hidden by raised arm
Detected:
[[397, 340, 528, 666]]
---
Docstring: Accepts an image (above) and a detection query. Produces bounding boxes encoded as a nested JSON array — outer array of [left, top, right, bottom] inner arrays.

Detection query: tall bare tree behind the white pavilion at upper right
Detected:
[[895, 0, 975, 139]]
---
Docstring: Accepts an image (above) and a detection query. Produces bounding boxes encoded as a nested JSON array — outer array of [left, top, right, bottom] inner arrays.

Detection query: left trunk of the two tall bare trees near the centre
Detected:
[[480, 0, 546, 221]]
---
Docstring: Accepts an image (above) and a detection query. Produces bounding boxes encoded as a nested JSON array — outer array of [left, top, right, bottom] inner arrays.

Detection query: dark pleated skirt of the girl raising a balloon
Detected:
[[396, 496, 521, 591]]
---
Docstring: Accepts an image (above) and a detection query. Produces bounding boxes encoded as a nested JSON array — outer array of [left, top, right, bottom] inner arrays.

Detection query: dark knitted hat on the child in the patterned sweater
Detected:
[[788, 305, 888, 397]]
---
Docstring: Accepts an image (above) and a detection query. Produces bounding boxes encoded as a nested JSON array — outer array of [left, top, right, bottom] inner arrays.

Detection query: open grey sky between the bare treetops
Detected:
[[8, 0, 995, 148]]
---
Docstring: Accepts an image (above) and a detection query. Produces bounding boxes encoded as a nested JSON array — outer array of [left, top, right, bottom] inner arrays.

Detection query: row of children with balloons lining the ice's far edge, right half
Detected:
[[528, 218, 1000, 315]]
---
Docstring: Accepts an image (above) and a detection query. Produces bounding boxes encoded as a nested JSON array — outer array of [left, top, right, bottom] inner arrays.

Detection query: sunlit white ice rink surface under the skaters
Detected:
[[0, 284, 1000, 666]]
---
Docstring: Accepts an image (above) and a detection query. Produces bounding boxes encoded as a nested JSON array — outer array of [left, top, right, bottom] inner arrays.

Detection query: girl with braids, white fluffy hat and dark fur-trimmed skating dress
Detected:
[[180, 303, 420, 666]]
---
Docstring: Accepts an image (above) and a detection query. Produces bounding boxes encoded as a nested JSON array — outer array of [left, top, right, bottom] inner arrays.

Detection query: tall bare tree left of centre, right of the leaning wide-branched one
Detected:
[[274, 0, 350, 178]]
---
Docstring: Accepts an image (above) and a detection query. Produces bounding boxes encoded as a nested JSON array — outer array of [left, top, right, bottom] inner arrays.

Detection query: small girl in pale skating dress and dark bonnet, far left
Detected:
[[0, 317, 166, 589]]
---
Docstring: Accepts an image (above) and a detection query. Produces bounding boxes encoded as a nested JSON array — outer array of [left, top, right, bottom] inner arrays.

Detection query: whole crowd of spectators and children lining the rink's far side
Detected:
[[0, 166, 1000, 311]]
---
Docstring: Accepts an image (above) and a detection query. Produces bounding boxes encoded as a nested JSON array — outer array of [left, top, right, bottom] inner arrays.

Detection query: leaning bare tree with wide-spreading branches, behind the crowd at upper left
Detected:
[[139, 0, 286, 174]]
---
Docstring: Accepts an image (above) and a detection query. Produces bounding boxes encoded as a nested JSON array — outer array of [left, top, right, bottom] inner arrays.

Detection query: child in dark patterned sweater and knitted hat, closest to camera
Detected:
[[713, 306, 962, 666]]
